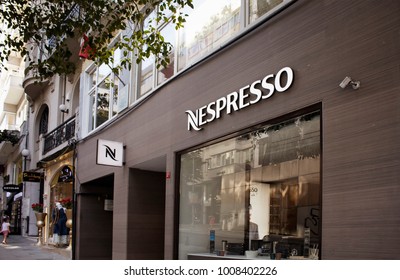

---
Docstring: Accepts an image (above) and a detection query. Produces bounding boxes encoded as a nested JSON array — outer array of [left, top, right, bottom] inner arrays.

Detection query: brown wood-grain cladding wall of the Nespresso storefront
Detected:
[[77, 0, 400, 259]]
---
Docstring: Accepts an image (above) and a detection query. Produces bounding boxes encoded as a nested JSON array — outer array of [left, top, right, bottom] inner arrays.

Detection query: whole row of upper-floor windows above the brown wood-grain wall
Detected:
[[82, 0, 293, 135]]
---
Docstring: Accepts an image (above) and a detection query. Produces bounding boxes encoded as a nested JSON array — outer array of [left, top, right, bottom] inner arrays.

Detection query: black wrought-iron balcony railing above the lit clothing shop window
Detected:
[[43, 116, 75, 155]]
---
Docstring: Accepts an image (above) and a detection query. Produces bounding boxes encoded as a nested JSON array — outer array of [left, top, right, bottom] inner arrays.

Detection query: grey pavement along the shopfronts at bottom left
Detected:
[[0, 235, 71, 260]]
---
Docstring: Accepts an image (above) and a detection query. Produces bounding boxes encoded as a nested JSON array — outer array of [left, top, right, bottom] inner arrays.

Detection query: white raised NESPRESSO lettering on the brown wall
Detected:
[[186, 67, 294, 130]]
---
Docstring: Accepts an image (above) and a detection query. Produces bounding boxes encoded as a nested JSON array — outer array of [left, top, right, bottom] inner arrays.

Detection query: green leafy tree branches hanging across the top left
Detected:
[[0, 0, 193, 78]]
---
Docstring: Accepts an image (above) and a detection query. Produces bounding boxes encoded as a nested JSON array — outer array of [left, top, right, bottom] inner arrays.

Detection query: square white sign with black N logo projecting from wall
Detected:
[[97, 139, 124, 166]]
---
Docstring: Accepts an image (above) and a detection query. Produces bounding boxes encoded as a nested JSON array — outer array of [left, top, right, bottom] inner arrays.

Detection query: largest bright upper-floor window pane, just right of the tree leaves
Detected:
[[178, 0, 241, 70]]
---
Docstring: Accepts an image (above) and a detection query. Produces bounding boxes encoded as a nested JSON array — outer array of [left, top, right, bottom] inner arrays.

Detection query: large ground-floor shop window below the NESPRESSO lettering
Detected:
[[179, 112, 321, 259]]
